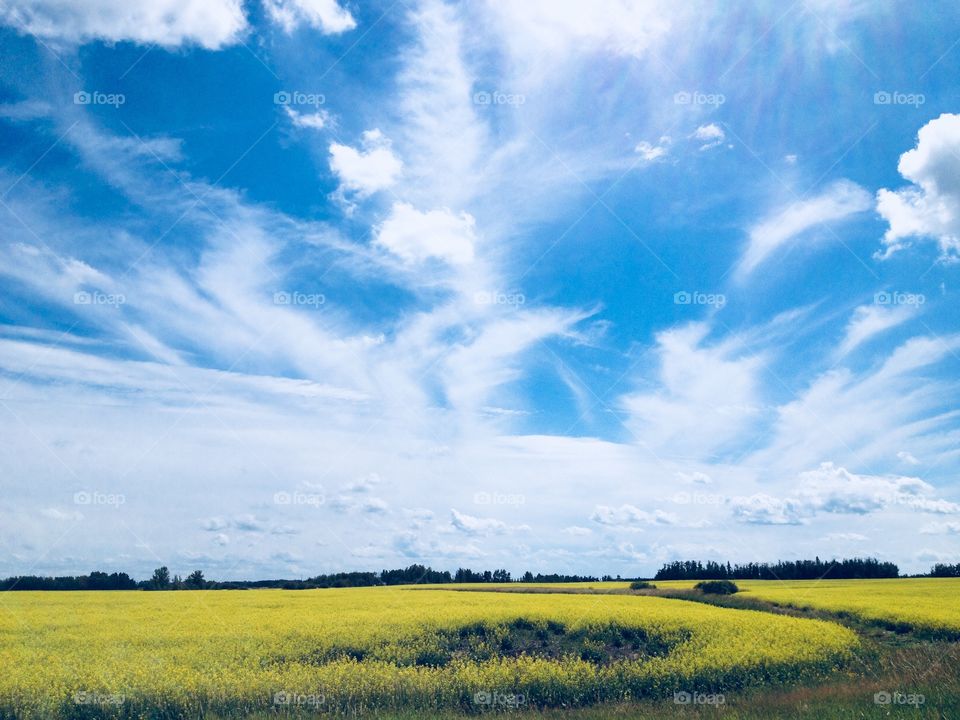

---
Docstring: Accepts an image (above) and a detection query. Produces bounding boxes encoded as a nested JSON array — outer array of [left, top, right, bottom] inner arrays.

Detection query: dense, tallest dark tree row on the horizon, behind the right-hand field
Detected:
[[653, 557, 900, 580]]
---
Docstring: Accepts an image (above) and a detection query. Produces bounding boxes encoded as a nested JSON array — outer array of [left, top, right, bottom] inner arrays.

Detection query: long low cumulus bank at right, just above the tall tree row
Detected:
[[732, 462, 960, 525]]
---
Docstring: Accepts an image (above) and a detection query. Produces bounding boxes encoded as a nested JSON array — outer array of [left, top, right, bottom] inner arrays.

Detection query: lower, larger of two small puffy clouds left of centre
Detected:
[[376, 202, 476, 265]]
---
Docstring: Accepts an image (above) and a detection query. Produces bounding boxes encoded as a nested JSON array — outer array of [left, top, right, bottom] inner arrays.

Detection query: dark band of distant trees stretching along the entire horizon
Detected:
[[0, 558, 960, 592]]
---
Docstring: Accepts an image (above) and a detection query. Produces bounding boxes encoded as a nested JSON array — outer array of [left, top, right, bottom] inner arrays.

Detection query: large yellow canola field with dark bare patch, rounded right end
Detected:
[[0, 588, 858, 720]]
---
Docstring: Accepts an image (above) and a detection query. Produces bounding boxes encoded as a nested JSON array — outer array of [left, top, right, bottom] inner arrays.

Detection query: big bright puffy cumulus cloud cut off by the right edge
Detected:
[[877, 113, 960, 260]]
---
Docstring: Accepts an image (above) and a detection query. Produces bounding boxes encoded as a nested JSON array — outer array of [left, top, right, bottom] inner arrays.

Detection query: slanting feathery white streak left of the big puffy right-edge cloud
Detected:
[[737, 180, 872, 278]]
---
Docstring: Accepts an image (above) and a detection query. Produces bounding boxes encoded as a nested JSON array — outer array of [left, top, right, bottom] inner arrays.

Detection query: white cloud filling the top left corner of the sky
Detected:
[[0, 0, 247, 50]]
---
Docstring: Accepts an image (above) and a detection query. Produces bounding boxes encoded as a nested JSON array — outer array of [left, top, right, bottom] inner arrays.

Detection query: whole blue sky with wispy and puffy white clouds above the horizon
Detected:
[[0, 0, 960, 579]]
